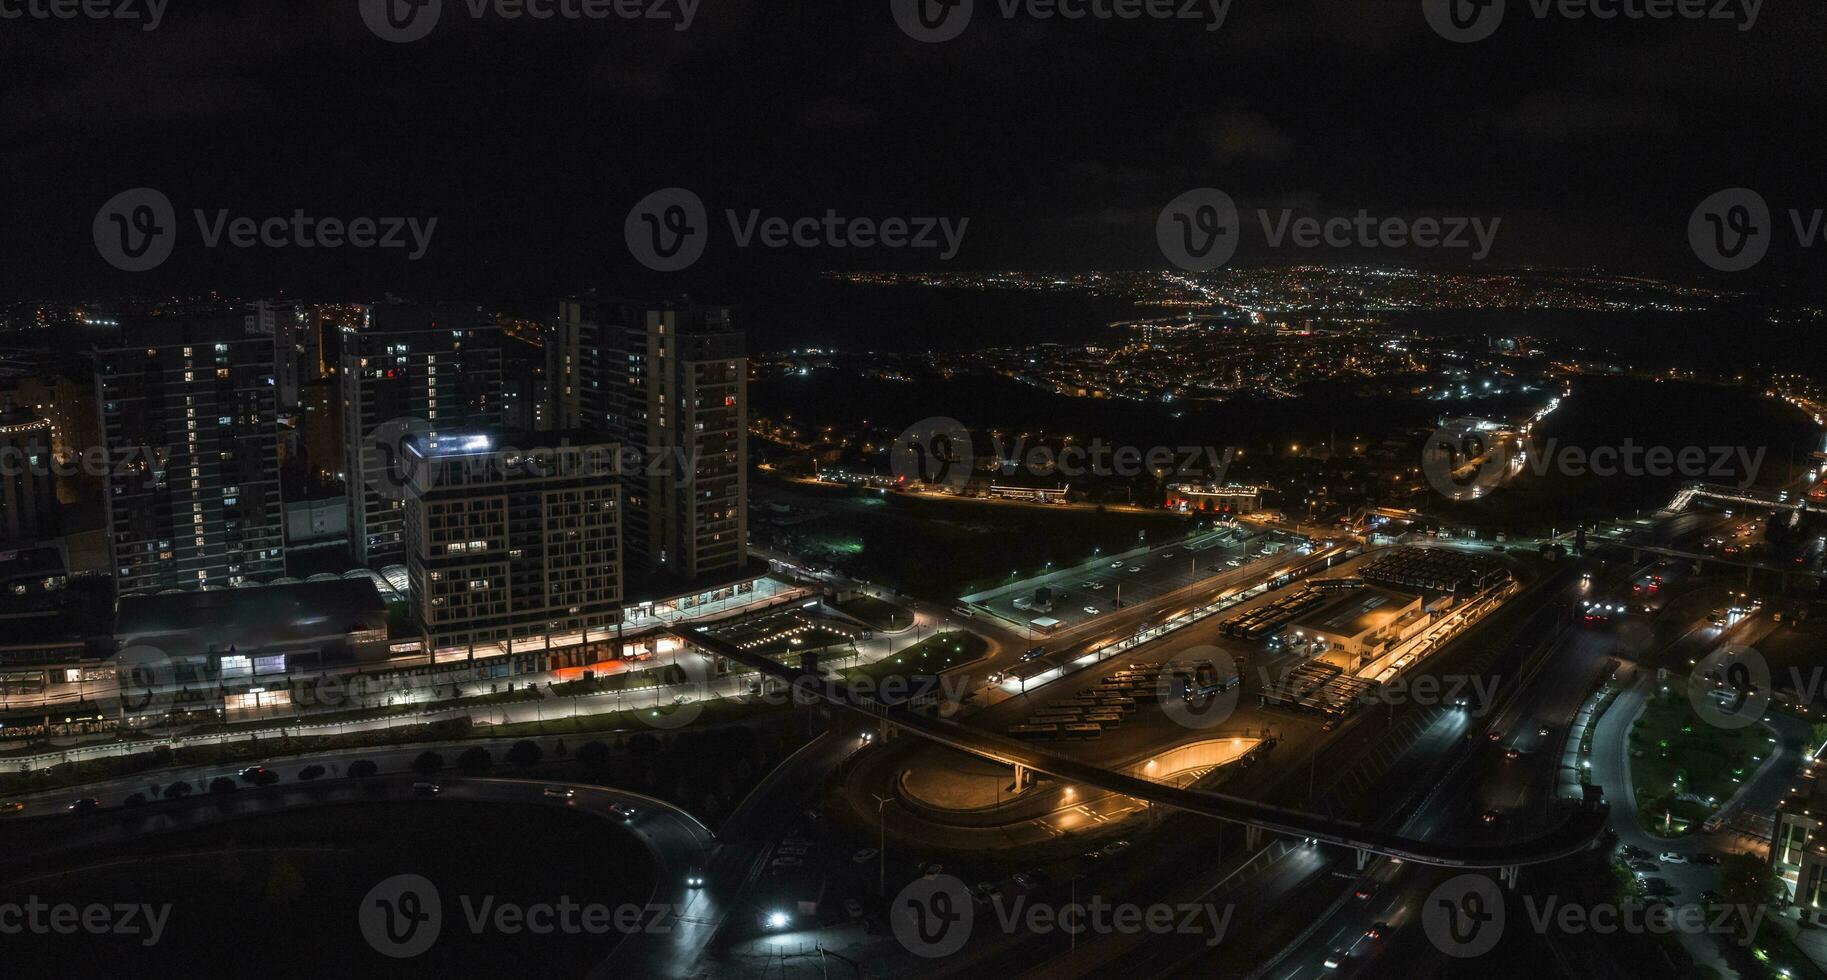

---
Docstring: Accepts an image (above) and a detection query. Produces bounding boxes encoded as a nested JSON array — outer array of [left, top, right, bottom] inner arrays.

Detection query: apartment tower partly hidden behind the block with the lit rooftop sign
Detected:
[[336, 304, 501, 565]]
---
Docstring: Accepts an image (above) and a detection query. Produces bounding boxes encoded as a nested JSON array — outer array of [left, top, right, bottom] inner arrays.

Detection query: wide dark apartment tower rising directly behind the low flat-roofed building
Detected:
[[95, 314, 285, 594]]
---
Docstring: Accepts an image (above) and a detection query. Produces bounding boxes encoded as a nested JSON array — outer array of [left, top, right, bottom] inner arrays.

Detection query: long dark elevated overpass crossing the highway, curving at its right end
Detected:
[[672, 625, 1608, 876]]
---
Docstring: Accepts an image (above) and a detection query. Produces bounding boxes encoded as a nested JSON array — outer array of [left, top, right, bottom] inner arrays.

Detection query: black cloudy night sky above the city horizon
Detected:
[[0, 0, 1827, 304]]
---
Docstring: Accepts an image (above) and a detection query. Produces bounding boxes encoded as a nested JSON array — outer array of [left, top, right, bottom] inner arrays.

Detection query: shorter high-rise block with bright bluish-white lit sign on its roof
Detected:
[[404, 431, 621, 662]]
